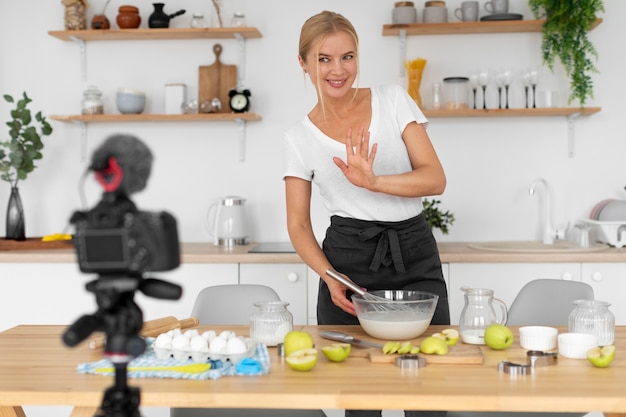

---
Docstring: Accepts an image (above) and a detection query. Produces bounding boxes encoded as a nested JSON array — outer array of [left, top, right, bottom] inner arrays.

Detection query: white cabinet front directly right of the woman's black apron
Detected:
[[448, 263, 581, 324]]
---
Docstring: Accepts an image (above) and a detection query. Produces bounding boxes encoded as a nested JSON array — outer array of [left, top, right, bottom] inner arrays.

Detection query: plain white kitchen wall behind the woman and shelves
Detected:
[[0, 0, 626, 241]]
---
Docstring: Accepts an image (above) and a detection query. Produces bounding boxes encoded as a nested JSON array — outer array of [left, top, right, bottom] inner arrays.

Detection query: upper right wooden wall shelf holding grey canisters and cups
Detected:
[[383, 18, 602, 36]]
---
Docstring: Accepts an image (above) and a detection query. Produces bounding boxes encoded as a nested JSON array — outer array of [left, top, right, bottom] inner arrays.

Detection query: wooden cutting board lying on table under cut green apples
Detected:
[[350, 342, 483, 364]]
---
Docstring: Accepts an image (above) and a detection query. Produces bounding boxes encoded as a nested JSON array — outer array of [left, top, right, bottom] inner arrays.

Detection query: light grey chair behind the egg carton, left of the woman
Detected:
[[170, 284, 326, 417]]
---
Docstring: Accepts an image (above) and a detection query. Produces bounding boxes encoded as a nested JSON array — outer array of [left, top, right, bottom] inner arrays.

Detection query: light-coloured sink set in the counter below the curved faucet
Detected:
[[468, 240, 608, 253]]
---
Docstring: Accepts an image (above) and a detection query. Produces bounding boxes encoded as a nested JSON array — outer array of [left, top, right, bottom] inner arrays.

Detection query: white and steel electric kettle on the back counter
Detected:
[[205, 196, 248, 246]]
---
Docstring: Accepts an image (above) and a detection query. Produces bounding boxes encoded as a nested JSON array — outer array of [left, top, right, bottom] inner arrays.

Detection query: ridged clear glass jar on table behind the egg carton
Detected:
[[250, 301, 293, 346]]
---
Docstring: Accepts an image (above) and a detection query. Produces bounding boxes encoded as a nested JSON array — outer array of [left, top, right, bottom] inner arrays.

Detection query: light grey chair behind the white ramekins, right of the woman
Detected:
[[447, 279, 594, 417]]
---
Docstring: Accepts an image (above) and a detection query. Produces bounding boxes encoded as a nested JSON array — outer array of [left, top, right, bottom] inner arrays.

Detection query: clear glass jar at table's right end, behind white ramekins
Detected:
[[568, 300, 615, 346]]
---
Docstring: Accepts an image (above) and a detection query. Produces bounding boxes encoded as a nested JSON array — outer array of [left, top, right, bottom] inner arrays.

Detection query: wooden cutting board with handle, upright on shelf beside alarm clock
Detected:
[[198, 43, 237, 113]]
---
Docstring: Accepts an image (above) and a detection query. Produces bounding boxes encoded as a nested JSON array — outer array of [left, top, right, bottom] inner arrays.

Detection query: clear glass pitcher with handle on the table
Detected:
[[459, 287, 508, 345]]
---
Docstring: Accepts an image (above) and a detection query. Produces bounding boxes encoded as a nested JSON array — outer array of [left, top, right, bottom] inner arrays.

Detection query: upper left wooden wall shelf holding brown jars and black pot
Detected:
[[48, 27, 261, 41]]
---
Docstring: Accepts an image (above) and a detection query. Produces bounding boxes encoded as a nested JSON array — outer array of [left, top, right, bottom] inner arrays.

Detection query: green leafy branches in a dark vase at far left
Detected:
[[0, 92, 52, 240]]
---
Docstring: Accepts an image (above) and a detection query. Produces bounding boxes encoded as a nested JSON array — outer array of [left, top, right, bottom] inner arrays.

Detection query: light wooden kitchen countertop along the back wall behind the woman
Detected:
[[0, 242, 626, 263]]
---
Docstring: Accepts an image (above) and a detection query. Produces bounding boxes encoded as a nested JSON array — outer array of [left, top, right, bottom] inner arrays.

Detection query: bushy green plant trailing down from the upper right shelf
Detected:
[[528, 0, 604, 107]]
